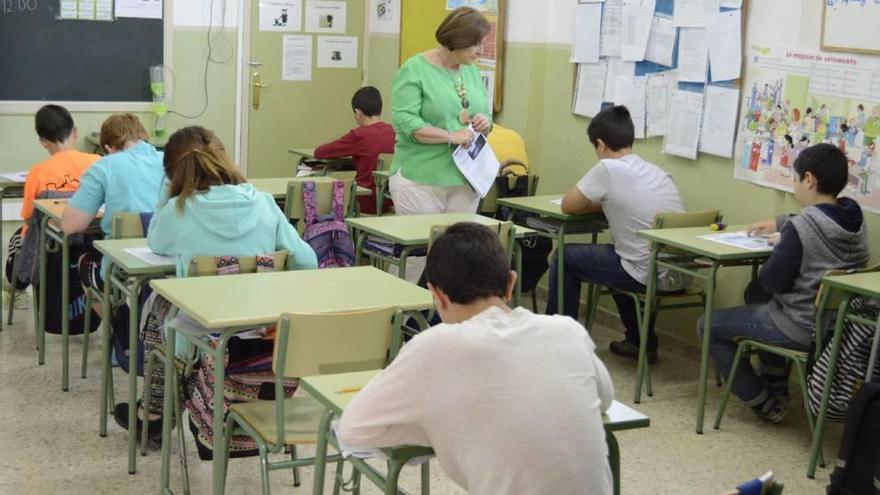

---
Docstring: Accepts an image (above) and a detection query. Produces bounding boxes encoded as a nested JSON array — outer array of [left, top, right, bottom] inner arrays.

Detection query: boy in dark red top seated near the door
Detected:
[[315, 86, 394, 213]]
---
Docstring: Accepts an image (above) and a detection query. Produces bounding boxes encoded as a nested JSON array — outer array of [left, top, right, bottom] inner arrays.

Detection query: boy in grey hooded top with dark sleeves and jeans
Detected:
[[697, 144, 869, 423]]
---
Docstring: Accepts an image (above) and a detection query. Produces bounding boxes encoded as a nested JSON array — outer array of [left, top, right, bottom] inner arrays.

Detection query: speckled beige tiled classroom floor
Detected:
[[0, 296, 841, 495]]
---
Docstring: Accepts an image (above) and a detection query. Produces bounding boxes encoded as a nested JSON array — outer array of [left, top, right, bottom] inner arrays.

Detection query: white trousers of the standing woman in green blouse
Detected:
[[388, 172, 480, 283]]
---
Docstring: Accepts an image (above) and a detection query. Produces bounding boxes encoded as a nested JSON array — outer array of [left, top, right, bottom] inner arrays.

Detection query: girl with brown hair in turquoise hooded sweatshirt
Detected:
[[115, 127, 318, 455]]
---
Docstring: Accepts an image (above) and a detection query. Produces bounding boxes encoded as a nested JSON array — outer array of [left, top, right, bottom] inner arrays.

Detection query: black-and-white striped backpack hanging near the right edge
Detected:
[[807, 297, 877, 421]]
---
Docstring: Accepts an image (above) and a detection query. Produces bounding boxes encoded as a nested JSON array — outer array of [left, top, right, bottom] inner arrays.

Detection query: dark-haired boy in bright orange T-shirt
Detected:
[[6, 105, 101, 289]]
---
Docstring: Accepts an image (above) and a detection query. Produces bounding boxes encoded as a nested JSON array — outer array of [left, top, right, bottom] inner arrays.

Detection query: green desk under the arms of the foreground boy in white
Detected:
[[299, 370, 651, 495]]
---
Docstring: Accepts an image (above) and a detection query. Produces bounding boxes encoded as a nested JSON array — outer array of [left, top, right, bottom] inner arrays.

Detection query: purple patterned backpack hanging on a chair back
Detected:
[[303, 181, 355, 268]]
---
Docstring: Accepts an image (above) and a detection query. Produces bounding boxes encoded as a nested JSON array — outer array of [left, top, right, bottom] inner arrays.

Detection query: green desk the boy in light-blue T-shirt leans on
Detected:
[[34, 199, 102, 392]]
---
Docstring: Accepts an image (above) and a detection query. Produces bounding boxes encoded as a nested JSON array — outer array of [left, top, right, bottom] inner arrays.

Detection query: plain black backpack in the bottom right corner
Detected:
[[827, 381, 880, 495]]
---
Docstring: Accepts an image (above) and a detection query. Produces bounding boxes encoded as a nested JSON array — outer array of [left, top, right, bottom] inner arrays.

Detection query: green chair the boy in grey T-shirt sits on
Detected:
[[586, 210, 721, 404]]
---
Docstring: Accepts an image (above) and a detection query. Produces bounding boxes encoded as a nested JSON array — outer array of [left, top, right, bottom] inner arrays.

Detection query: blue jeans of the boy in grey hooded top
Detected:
[[697, 304, 809, 406]]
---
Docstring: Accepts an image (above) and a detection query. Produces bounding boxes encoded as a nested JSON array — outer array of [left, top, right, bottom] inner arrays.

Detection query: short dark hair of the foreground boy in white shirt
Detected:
[[425, 222, 510, 304]]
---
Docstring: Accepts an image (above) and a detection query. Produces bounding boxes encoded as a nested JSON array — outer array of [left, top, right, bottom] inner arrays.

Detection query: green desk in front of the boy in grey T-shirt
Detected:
[[498, 194, 608, 314]]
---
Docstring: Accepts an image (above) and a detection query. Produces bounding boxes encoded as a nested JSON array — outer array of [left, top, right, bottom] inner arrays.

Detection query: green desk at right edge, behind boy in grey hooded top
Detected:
[[807, 271, 880, 478]]
